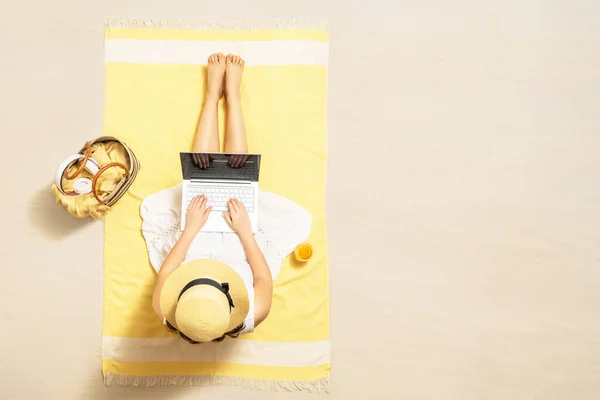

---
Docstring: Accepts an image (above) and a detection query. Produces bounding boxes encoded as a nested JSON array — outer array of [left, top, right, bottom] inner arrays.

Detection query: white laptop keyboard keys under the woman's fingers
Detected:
[[185, 184, 254, 212]]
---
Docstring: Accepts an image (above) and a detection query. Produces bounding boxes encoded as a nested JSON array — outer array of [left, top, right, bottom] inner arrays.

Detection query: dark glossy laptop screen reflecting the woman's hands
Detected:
[[179, 153, 260, 182]]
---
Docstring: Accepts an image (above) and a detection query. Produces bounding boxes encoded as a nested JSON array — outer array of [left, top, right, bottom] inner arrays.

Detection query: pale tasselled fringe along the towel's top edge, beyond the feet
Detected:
[[105, 18, 328, 30]]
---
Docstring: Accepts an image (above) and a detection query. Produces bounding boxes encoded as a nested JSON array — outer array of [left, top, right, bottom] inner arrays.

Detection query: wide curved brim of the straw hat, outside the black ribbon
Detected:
[[160, 259, 250, 333]]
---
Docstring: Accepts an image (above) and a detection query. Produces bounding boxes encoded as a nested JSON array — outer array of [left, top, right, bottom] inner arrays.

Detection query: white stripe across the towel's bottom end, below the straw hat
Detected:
[[102, 336, 330, 367]]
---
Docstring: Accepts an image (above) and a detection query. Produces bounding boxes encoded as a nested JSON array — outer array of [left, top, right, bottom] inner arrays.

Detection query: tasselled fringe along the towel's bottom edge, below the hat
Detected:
[[104, 372, 329, 393]]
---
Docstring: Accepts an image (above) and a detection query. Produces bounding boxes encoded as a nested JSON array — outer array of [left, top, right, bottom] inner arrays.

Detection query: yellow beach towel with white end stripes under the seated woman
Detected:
[[102, 20, 330, 392]]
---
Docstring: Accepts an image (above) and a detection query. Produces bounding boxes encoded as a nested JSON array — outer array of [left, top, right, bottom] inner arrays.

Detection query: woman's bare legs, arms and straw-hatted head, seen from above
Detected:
[[152, 53, 273, 343]]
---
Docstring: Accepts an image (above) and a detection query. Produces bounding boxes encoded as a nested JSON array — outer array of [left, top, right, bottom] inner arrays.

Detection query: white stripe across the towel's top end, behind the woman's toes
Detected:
[[104, 39, 329, 66]]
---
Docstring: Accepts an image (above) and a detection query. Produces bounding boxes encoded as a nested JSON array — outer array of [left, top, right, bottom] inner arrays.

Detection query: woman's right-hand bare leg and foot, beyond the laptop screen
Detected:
[[225, 54, 248, 153]]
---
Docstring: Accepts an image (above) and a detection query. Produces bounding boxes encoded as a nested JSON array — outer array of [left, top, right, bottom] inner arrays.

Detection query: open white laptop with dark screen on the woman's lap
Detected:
[[180, 153, 260, 233]]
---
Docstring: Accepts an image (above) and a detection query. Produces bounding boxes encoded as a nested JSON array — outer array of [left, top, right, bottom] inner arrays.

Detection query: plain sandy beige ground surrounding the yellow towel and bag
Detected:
[[0, 0, 600, 400]]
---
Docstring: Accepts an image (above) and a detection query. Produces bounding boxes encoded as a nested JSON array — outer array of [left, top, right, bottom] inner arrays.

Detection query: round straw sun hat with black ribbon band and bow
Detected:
[[160, 259, 250, 342]]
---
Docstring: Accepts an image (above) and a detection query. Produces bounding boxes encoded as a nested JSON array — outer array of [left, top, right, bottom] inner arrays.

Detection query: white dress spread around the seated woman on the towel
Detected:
[[140, 185, 312, 334]]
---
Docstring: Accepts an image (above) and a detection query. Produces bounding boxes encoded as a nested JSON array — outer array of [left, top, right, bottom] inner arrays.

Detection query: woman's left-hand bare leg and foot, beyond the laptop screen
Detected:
[[193, 53, 225, 153]]
